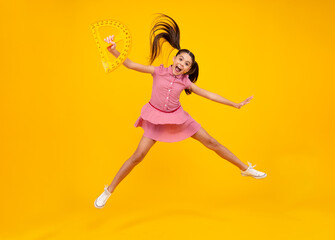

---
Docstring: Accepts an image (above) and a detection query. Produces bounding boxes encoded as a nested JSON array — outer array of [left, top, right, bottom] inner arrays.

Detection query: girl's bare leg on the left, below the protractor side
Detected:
[[107, 136, 156, 193]]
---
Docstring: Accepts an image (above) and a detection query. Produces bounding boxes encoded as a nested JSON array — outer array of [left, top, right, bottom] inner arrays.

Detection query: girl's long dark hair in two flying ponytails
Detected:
[[150, 14, 199, 95]]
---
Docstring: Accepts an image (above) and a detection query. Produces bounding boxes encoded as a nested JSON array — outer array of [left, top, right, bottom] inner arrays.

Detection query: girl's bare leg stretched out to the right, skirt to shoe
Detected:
[[192, 128, 248, 171]]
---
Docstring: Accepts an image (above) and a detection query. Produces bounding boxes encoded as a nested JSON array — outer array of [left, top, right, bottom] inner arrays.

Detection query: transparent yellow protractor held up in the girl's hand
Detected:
[[91, 20, 131, 73]]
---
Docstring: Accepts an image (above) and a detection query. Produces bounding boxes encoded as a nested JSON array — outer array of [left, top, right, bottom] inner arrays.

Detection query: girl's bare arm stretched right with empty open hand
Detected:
[[191, 83, 253, 109]]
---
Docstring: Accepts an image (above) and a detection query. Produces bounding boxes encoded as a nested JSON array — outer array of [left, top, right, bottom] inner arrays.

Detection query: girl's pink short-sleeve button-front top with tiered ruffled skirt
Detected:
[[134, 64, 201, 142]]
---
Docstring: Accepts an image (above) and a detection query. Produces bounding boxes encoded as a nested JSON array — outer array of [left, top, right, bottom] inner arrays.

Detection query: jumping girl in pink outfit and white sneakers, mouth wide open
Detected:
[[94, 15, 267, 208]]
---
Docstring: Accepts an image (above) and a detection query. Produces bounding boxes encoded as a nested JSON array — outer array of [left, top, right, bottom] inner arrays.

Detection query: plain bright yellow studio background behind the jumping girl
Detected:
[[0, 0, 335, 239]]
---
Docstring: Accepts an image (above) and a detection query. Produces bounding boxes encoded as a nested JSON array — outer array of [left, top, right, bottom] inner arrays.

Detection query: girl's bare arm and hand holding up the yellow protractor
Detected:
[[104, 35, 155, 74]]
